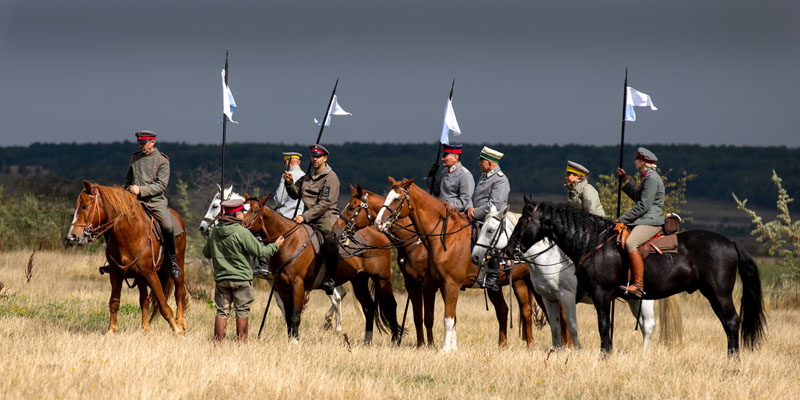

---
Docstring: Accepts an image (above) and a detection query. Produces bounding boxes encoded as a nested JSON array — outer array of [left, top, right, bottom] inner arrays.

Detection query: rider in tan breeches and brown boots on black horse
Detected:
[[617, 147, 664, 297]]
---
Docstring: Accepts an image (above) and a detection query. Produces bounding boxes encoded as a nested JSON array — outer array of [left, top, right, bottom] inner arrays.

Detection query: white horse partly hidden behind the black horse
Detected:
[[472, 206, 655, 350]]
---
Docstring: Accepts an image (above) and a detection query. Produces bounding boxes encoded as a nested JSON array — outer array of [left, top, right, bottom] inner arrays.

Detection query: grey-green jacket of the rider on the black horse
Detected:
[[619, 169, 664, 226]]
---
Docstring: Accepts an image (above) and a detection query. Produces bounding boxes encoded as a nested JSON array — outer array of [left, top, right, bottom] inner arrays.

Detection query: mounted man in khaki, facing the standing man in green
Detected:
[[283, 144, 339, 295]]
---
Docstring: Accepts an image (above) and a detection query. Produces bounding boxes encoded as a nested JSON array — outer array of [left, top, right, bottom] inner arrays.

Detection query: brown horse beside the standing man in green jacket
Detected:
[[239, 194, 400, 344]]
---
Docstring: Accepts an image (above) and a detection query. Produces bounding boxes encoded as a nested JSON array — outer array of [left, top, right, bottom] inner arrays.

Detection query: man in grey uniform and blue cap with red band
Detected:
[[437, 144, 475, 213]]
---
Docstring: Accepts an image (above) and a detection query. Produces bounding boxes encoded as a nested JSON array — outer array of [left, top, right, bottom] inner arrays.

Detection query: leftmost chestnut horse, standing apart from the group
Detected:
[[67, 181, 187, 335]]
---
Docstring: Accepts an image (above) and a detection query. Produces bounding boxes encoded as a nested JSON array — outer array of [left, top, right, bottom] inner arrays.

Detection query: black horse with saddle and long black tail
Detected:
[[506, 196, 766, 356]]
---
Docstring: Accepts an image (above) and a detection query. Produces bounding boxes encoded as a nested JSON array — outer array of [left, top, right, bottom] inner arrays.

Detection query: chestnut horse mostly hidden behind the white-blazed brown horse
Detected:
[[341, 185, 552, 347]]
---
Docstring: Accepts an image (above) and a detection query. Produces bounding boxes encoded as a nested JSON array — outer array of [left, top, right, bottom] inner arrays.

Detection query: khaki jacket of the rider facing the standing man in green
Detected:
[[284, 165, 339, 231]]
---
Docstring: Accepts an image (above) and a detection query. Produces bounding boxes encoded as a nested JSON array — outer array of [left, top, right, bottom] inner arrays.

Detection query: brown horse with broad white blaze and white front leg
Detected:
[[375, 177, 533, 352]]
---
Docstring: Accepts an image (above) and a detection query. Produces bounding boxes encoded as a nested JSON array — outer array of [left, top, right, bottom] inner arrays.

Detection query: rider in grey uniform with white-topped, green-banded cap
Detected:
[[467, 146, 511, 291]]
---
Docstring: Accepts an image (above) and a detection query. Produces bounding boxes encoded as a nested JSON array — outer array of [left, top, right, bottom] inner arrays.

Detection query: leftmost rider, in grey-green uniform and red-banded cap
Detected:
[[122, 130, 181, 279]]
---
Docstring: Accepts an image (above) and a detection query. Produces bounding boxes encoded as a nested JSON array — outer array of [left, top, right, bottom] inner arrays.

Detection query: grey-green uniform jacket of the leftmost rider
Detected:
[[123, 149, 169, 208]]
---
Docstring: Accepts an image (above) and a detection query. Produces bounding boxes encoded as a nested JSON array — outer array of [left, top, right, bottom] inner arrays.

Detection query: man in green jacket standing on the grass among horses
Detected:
[[203, 199, 284, 343]]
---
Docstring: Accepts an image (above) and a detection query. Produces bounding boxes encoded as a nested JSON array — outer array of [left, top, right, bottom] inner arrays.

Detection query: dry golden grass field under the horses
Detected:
[[0, 250, 800, 400]]
